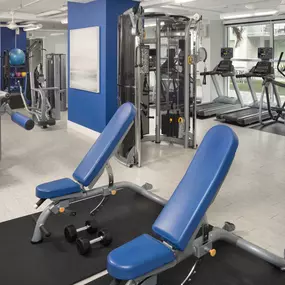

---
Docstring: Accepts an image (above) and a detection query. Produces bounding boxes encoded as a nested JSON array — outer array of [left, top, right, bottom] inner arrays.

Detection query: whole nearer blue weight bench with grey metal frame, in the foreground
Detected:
[[107, 125, 285, 285]]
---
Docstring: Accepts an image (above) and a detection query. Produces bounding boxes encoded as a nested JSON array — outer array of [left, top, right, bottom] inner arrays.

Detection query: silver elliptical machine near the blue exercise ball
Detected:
[[18, 64, 61, 129]]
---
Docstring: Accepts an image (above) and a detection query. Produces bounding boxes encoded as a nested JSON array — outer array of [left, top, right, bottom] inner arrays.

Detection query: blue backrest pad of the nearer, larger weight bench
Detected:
[[153, 125, 238, 251]]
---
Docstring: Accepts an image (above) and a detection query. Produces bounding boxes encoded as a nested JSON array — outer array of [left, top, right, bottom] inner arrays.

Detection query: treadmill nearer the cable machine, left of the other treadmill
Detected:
[[197, 48, 243, 118]]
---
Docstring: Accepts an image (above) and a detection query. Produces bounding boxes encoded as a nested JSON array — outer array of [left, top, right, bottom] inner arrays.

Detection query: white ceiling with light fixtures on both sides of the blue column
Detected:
[[0, 0, 282, 29]]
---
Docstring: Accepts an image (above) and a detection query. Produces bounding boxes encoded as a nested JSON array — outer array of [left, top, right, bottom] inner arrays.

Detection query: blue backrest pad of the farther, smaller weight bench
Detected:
[[73, 103, 136, 186]]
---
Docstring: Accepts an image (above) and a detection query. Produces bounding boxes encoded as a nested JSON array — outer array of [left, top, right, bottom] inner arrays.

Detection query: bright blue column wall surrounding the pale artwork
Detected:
[[68, 0, 134, 132]]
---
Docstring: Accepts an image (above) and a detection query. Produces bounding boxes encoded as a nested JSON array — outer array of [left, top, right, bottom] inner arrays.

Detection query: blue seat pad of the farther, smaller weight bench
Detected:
[[36, 178, 81, 199]]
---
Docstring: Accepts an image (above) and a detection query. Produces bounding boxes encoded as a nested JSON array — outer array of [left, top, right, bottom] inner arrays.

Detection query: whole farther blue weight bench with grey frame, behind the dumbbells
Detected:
[[31, 103, 166, 243]]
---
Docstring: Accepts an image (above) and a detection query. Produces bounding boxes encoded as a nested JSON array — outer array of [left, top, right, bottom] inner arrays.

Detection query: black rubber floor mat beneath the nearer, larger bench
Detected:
[[88, 242, 285, 285]]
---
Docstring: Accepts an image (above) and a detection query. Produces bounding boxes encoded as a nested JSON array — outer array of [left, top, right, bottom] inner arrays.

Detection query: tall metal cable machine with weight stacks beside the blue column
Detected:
[[117, 7, 204, 167]]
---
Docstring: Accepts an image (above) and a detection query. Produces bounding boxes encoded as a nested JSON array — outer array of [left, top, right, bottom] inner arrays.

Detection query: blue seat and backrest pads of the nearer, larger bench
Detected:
[[107, 125, 238, 280]]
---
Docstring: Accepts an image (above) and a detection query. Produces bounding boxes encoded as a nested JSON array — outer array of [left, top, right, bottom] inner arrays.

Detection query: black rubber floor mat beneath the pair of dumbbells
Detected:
[[0, 190, 162, 285]]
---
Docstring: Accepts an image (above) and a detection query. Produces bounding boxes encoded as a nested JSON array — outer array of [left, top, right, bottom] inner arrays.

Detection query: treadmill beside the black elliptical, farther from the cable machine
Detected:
[[217, 48, 274, 127]]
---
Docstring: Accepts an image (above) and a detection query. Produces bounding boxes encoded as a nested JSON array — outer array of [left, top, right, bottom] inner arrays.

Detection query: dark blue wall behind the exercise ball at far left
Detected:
[[0, 28, 27, 89]]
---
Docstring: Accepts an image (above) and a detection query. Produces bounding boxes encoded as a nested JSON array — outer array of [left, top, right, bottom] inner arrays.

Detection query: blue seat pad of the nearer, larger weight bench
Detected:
[[107, 235, 175, 280]]
